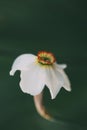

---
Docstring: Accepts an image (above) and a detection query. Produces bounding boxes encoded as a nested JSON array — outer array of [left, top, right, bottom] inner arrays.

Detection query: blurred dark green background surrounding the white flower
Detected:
[[0, 0, 87, 130]]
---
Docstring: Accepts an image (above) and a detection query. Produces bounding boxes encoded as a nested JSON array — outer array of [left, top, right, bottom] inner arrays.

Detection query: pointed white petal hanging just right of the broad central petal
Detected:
[[45, 67, 63, 99]]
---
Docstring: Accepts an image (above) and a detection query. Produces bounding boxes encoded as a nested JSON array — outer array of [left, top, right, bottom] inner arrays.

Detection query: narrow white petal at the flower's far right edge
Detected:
[[55, 64, 71, 91]]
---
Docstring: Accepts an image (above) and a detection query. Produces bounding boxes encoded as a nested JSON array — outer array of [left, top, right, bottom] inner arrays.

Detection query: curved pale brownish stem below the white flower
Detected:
[[34, 93, 53, 121]]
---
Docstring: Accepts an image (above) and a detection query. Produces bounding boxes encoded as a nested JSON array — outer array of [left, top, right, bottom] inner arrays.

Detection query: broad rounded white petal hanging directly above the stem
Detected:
[[20, 64, 45, 95]]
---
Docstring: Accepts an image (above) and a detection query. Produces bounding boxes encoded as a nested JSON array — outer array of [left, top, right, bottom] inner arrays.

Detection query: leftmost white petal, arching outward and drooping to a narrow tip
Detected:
[[10, 54, 36, 75]]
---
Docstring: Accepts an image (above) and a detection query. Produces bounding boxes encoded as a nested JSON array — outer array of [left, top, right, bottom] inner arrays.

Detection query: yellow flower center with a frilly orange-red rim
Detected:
[[37, 51, 56, 65]]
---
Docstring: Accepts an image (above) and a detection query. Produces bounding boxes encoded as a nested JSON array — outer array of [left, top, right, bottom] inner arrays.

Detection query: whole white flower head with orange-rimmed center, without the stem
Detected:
[[10, 51, 71, 99]]
